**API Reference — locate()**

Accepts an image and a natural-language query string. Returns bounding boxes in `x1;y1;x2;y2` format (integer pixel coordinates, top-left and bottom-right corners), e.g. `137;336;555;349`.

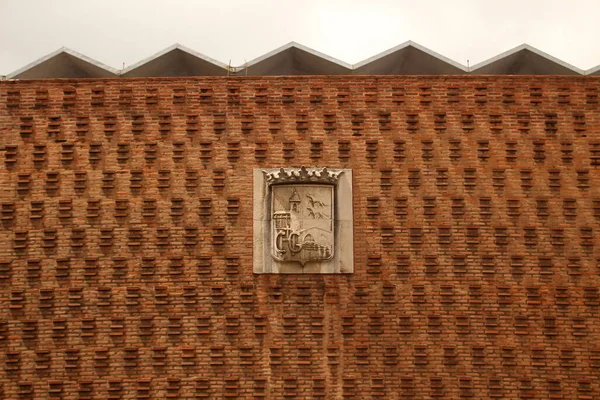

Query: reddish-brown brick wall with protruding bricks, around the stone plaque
0;77;600;399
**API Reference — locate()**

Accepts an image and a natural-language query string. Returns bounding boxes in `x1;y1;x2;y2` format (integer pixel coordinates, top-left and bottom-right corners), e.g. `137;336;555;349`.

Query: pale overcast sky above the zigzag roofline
0;0;600;75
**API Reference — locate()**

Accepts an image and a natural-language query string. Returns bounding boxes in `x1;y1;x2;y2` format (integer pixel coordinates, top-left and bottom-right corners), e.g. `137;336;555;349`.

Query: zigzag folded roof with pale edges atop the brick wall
6;41;600;79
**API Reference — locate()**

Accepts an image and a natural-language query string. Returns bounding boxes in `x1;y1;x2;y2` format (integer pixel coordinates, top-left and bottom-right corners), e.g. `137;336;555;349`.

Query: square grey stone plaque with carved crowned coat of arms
254;167;354;273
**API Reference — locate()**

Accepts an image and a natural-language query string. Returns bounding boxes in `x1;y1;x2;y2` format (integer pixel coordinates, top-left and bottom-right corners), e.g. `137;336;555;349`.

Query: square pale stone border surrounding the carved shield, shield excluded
253;168;354;274
